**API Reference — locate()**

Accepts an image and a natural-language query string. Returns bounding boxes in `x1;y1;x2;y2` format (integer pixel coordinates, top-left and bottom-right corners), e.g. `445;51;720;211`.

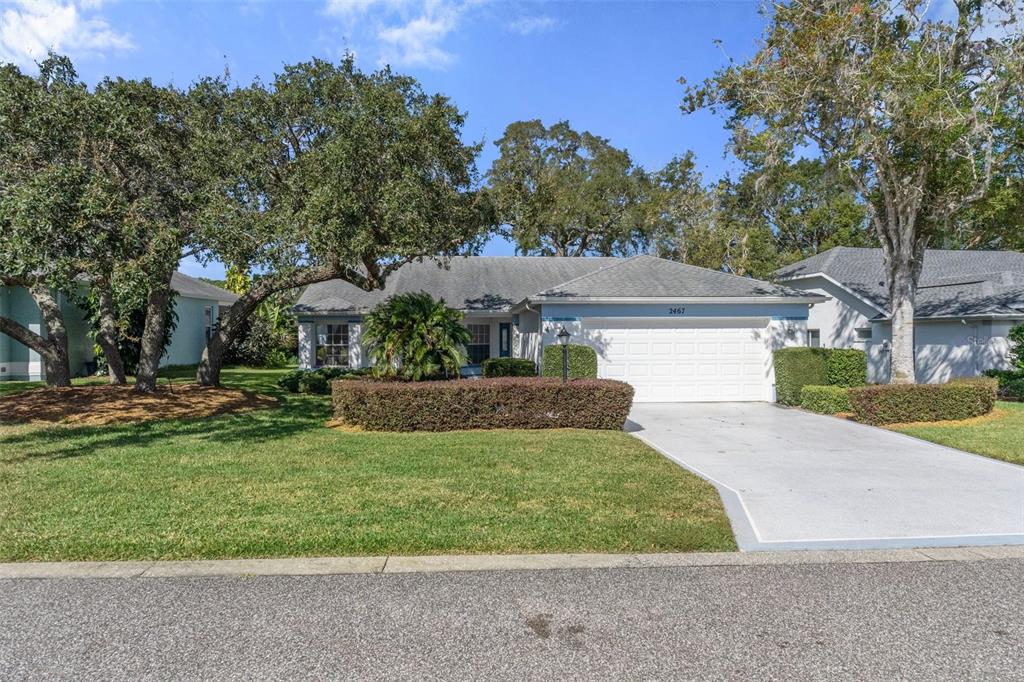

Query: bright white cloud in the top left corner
0;0;134;67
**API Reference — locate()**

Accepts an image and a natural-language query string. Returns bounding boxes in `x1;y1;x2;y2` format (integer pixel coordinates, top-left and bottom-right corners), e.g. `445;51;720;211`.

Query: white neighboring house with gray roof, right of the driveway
776;247;1024;383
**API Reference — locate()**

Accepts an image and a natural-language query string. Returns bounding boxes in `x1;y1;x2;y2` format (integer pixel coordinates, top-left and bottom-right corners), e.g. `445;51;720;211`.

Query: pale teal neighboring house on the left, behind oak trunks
0;272;238;381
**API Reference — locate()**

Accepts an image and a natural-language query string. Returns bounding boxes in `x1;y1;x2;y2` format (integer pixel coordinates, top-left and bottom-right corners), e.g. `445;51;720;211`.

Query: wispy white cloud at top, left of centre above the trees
325;0;475;69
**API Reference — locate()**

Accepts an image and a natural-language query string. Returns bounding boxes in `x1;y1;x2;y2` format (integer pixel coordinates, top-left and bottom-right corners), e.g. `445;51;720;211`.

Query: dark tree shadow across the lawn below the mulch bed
0;387;331;464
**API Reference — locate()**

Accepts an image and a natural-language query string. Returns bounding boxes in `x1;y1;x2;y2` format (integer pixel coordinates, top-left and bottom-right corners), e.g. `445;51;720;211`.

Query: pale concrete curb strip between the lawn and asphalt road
0;545;1024;580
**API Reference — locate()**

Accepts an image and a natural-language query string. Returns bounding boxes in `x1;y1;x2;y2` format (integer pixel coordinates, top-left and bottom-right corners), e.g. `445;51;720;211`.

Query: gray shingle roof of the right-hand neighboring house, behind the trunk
776;247;1024;317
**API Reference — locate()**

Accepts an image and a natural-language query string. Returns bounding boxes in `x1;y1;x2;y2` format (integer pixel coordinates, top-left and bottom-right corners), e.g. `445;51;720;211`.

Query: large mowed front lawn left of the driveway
0;370;735;561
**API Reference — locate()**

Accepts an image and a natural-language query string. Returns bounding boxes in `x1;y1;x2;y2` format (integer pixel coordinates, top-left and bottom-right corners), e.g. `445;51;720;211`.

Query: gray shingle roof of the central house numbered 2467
294;251;823;313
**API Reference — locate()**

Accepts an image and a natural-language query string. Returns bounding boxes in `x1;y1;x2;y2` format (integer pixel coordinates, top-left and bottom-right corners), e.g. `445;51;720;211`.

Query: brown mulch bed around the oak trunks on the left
0;384;276;426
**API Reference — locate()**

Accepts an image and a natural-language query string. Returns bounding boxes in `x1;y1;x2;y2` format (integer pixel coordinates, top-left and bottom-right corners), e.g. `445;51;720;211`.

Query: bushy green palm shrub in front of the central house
362;292;472;381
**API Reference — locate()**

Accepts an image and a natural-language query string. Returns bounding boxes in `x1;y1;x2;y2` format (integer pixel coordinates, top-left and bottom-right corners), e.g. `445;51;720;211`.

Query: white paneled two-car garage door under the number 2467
583;317;770;402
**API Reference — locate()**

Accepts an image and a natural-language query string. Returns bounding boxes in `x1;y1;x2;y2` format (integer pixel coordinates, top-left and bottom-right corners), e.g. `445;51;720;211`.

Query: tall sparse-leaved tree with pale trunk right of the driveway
683;0;1024;383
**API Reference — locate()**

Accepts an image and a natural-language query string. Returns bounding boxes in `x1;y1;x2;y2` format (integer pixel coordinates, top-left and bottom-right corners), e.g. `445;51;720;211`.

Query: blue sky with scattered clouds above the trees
0;0;763;276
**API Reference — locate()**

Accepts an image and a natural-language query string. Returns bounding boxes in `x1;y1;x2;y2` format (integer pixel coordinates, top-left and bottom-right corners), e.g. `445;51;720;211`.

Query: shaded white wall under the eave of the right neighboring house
867;319;1015;384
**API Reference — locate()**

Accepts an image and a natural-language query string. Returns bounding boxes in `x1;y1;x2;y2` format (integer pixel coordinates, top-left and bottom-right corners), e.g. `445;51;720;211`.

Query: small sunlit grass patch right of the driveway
893;402;1024;464
